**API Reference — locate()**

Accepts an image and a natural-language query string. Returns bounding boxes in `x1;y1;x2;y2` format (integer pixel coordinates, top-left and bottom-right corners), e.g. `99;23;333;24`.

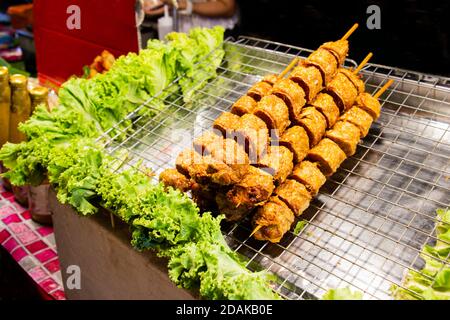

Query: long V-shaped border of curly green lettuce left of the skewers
0;27;279;299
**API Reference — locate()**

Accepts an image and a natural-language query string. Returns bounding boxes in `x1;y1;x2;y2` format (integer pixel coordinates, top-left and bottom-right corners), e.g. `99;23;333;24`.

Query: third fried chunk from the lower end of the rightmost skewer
289;160;327;196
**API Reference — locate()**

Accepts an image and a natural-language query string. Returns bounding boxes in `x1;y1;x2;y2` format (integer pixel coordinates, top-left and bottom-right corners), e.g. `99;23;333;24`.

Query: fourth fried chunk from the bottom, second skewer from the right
296;107;327;148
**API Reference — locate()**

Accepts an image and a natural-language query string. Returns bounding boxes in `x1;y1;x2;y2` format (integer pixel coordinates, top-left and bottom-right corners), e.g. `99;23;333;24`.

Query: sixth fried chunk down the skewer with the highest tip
235;114;269;162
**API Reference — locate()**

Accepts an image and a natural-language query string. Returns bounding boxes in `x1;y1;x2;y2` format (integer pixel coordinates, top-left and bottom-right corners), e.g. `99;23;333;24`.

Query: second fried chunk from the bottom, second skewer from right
256;146;294;186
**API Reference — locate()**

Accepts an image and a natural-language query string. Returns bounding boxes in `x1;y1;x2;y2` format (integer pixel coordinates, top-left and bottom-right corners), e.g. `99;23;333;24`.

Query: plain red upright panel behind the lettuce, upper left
33;0;139;88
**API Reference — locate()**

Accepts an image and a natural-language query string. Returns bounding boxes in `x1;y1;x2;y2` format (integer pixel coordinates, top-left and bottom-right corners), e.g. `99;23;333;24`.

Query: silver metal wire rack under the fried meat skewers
99;37;450;299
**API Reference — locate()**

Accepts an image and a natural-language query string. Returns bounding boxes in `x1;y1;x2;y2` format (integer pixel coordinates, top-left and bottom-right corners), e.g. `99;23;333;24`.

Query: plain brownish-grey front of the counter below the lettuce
49;190;195;300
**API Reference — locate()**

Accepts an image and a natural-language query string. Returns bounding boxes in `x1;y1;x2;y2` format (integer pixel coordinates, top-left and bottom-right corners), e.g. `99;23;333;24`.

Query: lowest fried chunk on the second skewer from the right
227;166;275;208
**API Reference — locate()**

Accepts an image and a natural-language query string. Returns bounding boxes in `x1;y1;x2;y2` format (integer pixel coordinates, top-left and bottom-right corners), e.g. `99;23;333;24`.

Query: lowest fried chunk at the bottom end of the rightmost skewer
253;196;295;243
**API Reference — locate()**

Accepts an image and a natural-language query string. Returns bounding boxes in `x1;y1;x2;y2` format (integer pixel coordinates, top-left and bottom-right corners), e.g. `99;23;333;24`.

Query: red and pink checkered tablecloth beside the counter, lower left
0;183;65;300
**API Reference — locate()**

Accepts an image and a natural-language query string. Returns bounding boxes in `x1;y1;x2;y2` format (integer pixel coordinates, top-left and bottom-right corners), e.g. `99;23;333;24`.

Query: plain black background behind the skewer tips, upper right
237;0;450;76
